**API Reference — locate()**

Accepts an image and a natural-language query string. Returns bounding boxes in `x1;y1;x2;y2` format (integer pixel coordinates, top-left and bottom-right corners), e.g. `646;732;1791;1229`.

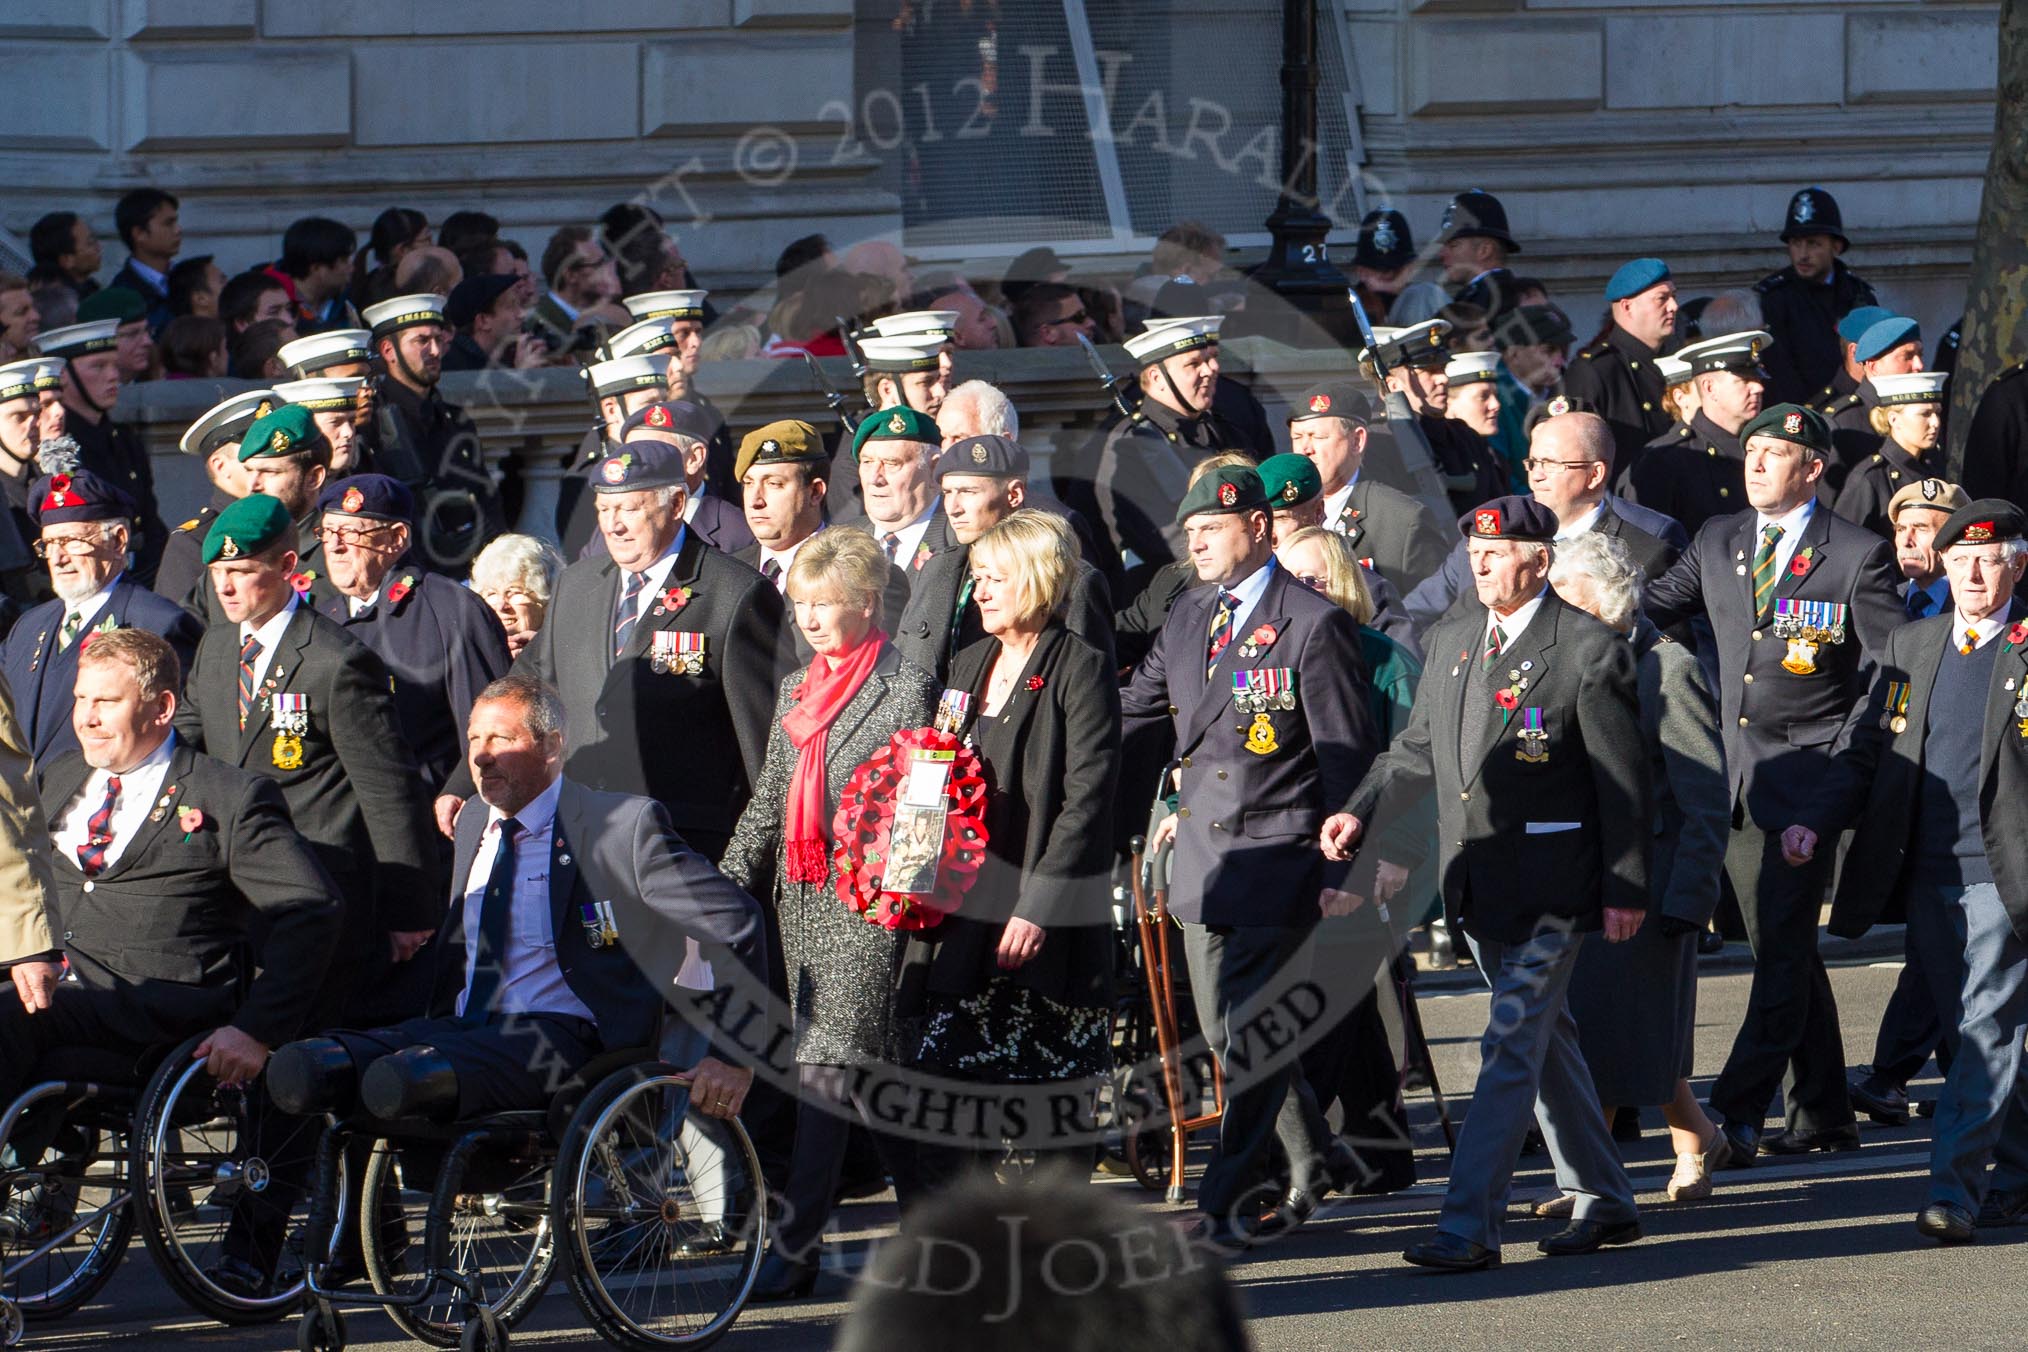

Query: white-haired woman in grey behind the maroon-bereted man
1537;531;1732;1214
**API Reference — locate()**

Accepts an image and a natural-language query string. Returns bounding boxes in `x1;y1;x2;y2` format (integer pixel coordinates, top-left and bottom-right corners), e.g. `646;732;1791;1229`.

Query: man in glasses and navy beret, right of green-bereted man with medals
316;474;509;799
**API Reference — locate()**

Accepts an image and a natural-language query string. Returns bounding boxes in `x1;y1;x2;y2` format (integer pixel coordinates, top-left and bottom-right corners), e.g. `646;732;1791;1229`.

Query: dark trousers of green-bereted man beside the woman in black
1182;924;1332;1224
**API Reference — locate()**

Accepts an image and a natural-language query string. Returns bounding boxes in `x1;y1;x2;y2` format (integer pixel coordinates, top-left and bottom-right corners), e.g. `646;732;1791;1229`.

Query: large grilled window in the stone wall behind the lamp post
896;0;1361;247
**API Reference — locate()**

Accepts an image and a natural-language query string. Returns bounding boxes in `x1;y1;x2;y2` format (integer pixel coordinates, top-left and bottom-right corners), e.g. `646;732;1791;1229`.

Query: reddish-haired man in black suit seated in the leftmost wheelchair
0;628;339;1243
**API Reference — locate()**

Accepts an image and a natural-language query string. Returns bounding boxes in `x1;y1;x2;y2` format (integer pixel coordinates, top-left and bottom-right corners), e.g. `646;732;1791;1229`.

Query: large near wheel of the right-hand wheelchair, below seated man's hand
556;1064;767;1352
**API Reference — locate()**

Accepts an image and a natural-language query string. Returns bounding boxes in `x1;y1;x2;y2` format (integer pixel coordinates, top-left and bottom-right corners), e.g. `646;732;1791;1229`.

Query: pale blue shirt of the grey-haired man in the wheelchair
458;778;592;1022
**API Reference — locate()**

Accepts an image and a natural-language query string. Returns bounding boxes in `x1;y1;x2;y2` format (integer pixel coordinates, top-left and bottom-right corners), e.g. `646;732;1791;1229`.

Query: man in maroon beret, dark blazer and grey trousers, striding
1322;497;1651;1271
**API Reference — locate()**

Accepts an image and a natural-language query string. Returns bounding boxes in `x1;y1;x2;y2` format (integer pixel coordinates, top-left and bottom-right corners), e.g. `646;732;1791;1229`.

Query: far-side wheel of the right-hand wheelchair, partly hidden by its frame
359;1141;556;1348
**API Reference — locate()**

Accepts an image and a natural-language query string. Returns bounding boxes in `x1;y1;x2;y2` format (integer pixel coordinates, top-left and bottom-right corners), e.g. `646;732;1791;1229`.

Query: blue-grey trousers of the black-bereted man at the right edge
1908;882;2028;1212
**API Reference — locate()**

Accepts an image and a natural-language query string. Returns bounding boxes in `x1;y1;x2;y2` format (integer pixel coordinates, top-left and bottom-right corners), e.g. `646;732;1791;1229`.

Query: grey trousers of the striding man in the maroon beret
1436;930;1639;1249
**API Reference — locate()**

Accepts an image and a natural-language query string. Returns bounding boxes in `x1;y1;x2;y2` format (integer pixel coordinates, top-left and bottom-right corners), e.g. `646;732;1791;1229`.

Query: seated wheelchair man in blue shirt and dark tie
268;675;767;1175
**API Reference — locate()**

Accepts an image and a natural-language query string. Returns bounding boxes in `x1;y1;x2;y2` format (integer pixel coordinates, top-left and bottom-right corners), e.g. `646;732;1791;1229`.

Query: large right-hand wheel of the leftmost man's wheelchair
134;1048;345;1324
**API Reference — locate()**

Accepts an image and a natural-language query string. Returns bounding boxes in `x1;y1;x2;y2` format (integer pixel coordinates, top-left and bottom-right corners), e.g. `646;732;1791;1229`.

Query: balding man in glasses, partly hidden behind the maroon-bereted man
1403;409;1689;632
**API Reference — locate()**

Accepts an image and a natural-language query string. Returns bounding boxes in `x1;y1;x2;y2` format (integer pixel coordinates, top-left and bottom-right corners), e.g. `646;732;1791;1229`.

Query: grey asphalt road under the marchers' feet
26;963;2028;1352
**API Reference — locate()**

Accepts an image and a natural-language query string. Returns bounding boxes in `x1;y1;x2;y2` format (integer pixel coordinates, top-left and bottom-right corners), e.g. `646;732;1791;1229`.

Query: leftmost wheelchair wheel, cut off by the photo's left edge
0;1091;134;1324
